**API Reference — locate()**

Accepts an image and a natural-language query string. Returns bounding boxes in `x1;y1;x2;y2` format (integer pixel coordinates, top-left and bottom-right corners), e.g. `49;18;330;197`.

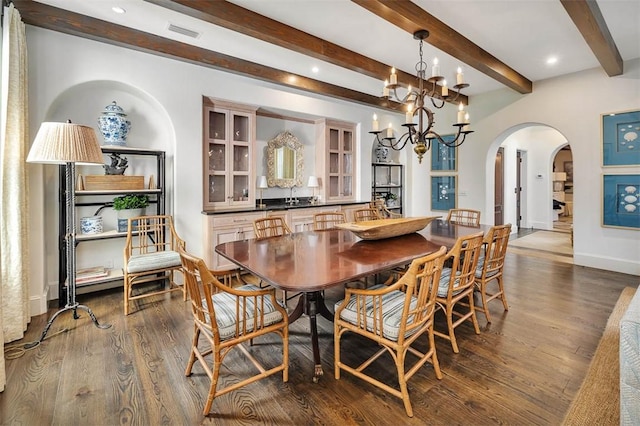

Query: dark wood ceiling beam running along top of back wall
13;0;402;112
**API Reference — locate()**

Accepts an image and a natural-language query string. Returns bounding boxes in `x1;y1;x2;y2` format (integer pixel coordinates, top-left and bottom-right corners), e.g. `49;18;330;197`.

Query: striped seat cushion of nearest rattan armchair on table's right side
334;284;416;341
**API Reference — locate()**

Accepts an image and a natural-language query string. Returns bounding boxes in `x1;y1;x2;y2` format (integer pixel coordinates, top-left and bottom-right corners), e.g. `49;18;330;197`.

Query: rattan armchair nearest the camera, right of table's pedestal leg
333;247;446;417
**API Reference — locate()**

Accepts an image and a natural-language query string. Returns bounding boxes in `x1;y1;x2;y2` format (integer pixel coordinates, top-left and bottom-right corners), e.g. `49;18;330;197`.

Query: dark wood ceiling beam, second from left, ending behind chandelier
144;0;469;105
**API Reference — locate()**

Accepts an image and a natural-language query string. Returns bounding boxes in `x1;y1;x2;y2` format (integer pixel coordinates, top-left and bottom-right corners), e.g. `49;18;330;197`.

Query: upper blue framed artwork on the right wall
602;111;640;167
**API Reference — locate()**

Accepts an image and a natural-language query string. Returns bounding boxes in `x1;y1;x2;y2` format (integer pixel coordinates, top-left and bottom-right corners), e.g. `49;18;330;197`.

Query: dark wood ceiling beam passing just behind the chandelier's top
351;0;533;93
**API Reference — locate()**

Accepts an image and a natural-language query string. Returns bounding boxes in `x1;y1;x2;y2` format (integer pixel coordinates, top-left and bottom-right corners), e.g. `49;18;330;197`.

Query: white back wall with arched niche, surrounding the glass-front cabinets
27;26;410;314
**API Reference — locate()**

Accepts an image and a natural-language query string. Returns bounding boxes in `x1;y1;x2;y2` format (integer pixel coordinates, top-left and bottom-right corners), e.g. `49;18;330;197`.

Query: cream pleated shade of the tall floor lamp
27;122;104;164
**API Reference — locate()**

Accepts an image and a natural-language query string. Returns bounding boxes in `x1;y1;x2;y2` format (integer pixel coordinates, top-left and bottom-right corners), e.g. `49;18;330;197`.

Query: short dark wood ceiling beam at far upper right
560;0;624;77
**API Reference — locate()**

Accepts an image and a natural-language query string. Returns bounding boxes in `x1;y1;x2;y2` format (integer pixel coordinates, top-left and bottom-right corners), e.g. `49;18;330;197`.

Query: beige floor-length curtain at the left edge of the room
0;4;30;391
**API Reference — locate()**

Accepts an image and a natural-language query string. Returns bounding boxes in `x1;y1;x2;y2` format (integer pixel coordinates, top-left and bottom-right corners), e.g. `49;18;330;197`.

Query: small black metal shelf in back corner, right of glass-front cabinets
371;163;404;214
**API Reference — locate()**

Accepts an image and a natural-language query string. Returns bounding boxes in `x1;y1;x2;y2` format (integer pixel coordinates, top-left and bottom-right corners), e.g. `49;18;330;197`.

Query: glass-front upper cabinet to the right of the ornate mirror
316;120;357;202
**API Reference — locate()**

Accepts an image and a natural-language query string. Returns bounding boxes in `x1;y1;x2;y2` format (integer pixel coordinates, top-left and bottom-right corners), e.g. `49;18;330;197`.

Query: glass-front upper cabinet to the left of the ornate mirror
202;97;257;211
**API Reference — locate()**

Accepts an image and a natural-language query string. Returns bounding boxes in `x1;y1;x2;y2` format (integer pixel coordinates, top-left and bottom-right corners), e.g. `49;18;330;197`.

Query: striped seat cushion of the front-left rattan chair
208;284;283;340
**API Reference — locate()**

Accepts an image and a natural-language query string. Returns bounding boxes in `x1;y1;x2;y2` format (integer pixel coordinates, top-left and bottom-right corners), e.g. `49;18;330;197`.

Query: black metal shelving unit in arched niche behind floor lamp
58;146;166;307
